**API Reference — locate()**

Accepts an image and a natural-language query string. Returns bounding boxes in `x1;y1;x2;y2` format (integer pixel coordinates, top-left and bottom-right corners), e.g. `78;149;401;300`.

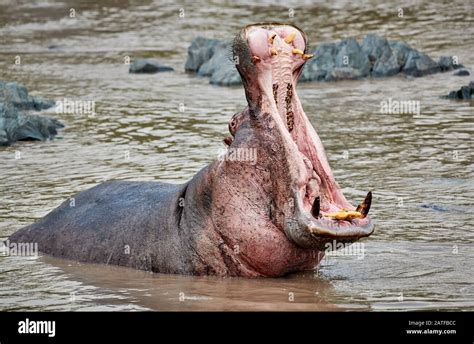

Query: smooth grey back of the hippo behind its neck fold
9;181;189;273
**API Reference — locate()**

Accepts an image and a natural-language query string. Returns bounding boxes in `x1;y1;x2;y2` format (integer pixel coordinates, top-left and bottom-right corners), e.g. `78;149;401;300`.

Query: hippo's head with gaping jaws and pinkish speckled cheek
207;24;374;276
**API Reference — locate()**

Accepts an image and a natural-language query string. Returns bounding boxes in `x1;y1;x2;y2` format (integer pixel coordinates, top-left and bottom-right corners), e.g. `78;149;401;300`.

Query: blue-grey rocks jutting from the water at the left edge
0;81;64;145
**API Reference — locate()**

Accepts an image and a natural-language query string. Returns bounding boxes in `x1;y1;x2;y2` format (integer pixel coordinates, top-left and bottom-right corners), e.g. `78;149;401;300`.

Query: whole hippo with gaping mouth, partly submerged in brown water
5;23;374;277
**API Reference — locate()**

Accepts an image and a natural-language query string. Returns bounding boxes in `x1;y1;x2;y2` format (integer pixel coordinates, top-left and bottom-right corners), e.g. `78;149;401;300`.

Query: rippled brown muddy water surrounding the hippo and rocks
0;0;474;310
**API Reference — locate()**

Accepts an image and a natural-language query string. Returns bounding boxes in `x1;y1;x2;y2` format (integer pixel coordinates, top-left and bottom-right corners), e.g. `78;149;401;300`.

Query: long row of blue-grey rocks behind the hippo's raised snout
185;33;462;85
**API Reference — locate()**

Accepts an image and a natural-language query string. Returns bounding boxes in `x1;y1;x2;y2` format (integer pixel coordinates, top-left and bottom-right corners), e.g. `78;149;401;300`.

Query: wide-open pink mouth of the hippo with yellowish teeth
231;24;374;250
